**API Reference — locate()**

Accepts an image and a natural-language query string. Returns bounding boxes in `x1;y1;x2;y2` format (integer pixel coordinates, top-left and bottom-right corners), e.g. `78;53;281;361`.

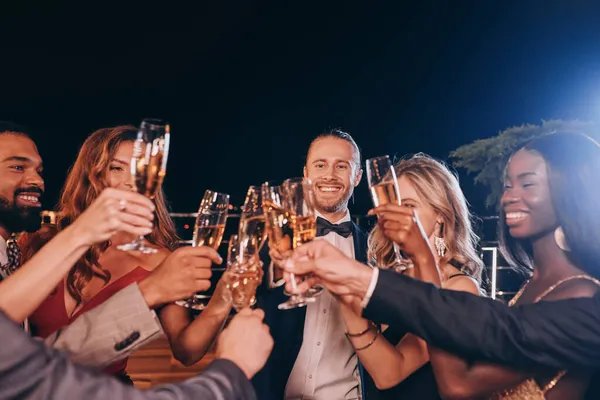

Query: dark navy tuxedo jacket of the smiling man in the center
252;223;371;400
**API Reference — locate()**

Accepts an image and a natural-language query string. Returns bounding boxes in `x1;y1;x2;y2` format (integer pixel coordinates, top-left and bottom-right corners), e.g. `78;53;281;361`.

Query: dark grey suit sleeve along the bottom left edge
0;312;256;400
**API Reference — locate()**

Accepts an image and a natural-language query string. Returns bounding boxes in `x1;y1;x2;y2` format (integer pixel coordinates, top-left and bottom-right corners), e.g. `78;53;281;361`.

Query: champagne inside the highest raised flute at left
131;135;169;199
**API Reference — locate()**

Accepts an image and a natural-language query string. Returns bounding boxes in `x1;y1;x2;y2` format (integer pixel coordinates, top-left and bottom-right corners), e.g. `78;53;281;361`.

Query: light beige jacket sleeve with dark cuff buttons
45;284;163;368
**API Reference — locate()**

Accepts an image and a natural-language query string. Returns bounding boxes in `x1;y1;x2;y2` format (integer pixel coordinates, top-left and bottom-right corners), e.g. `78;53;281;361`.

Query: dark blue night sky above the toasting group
0;0;600;228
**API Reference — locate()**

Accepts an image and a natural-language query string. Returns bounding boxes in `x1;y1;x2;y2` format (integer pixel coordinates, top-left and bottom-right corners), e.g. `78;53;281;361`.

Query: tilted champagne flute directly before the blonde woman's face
367;156;412;272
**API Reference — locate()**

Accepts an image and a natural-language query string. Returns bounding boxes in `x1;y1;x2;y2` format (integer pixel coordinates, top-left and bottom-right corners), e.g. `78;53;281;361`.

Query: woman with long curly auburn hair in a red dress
20;126;230;382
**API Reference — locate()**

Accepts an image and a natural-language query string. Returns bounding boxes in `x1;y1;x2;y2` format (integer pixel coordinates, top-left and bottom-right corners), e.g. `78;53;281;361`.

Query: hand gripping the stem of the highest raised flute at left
71;188;155;246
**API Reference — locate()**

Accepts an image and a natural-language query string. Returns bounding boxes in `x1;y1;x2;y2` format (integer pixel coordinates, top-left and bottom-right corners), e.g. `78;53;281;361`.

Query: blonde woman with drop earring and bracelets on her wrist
339;154;483;399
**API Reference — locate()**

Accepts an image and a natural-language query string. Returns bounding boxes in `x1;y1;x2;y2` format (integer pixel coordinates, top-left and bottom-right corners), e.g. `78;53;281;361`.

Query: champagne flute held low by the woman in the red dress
223;234;262;312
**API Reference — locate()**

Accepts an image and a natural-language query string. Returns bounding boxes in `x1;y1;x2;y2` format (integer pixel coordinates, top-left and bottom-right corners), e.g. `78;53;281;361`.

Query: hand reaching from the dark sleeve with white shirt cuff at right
278;240;373;298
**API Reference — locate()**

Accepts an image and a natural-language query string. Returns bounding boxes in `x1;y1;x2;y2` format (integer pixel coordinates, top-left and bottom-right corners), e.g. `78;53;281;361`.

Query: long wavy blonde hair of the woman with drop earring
368;153;483;283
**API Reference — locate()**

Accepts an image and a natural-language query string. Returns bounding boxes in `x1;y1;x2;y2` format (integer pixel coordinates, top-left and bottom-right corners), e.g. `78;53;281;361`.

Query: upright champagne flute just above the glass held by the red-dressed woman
238;186;267;251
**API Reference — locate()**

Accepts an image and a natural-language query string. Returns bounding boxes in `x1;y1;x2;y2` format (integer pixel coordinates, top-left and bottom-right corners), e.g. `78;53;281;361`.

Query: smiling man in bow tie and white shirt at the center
253;130;376;399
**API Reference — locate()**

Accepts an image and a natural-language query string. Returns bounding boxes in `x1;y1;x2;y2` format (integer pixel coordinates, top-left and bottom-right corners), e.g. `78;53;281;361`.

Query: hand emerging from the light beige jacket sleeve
139;246;223;308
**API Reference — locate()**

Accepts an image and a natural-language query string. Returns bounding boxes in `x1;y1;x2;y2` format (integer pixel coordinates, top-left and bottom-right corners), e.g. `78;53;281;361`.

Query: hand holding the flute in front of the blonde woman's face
369;203;433;262
